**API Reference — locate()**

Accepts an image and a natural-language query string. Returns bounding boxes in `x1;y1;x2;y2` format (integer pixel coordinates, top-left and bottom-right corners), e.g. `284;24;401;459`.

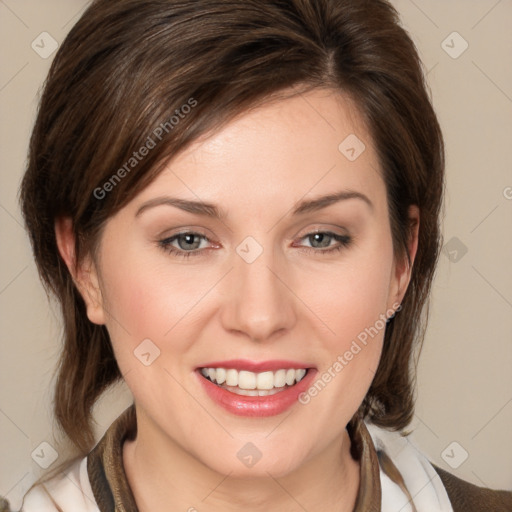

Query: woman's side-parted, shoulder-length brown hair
20;0;444;484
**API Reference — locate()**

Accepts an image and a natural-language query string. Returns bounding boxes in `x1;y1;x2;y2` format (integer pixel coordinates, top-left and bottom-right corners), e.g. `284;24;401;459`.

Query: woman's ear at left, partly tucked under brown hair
55;217;105;325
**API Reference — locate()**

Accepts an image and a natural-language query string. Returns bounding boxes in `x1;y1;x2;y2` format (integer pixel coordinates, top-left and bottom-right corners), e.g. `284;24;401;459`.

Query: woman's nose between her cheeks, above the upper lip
221;241;298;343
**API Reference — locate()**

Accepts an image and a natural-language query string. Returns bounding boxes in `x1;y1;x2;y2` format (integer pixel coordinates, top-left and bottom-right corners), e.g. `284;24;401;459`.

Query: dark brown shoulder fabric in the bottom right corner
432;464;512;512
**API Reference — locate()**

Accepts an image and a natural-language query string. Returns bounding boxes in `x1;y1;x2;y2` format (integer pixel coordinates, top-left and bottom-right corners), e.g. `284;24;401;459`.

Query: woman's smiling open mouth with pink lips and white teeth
196;360;317;416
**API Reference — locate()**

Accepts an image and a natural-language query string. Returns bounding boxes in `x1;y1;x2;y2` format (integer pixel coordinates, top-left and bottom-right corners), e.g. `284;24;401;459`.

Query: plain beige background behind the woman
0;0;512;508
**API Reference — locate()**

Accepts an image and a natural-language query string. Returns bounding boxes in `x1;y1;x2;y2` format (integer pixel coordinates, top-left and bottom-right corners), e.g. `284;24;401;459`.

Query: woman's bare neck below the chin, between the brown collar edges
123;410;360;512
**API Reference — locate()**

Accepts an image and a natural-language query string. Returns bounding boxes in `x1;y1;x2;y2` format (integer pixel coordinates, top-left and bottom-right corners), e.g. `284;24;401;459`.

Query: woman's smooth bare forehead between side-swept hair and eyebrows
127;89;385;215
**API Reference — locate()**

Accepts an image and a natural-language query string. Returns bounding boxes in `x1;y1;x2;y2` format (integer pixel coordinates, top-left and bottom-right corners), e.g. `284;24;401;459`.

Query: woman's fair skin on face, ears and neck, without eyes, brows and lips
56;89;419;512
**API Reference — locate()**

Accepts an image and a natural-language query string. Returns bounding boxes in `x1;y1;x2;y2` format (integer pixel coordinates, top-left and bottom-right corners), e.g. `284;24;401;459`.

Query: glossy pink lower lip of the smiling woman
196;368;317;417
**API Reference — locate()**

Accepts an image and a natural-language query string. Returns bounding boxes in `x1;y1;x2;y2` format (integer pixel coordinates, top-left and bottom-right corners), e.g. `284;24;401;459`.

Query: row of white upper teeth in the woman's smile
201;368;306;390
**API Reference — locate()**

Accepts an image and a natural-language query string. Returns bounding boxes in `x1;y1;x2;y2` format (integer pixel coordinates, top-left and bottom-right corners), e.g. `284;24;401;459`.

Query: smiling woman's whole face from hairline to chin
79;90;415;476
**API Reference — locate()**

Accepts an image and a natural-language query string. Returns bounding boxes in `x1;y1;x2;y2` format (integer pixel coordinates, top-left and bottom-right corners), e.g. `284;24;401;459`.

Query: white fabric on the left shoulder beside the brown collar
20;457;99;512
